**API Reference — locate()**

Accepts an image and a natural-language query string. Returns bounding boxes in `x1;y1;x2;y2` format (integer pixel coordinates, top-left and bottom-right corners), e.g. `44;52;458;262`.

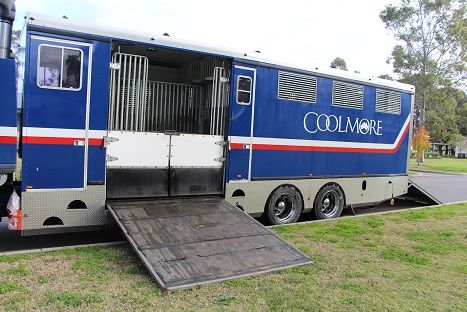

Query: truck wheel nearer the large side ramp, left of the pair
264;185;303;225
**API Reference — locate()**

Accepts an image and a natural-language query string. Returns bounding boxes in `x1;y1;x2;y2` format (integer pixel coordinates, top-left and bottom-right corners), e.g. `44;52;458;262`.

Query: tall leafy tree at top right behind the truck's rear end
380;0;467;132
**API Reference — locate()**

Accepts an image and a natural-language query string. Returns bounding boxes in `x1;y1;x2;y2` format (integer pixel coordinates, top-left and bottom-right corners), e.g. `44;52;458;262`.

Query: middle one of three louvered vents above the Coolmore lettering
332;81;363;109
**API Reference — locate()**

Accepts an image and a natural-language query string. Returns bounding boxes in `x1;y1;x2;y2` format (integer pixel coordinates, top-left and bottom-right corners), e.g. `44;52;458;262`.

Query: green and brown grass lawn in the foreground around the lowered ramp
0;204;467;311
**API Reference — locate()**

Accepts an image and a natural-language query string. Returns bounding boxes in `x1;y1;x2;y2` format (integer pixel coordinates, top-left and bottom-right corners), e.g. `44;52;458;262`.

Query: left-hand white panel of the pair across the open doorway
107;131;170;168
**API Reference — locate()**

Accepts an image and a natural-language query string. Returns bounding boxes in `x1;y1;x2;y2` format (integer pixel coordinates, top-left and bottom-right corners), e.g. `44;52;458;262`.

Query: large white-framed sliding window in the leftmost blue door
37;45;83;91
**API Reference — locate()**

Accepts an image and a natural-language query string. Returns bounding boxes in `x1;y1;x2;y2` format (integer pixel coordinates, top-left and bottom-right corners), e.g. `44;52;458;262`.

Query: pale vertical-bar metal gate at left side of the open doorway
109;53;149;131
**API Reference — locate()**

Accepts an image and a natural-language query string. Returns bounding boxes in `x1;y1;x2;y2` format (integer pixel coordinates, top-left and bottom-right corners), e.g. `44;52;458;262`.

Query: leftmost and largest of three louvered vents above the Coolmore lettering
277;71;316;103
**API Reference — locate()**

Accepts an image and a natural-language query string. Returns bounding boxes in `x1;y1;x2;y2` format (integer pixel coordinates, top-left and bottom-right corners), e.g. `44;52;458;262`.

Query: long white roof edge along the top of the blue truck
26;13;415;93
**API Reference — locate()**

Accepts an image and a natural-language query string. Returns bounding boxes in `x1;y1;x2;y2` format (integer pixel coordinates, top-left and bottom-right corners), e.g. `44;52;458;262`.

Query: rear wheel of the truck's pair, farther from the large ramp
313;184;345;220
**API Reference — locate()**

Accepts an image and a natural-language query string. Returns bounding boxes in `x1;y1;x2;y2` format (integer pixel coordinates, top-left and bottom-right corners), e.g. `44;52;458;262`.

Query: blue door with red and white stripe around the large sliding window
23;33;92;189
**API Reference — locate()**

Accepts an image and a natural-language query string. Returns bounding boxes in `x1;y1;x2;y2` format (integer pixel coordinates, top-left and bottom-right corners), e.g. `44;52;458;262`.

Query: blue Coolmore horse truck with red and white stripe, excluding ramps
0;4;414;235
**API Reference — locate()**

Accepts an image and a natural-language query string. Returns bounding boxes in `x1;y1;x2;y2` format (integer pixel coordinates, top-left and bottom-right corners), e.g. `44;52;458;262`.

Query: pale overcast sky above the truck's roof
14;0;398;76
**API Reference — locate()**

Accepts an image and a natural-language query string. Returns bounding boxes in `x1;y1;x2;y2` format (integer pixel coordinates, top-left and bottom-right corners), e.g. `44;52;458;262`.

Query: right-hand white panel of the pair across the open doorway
170;134;224;168
